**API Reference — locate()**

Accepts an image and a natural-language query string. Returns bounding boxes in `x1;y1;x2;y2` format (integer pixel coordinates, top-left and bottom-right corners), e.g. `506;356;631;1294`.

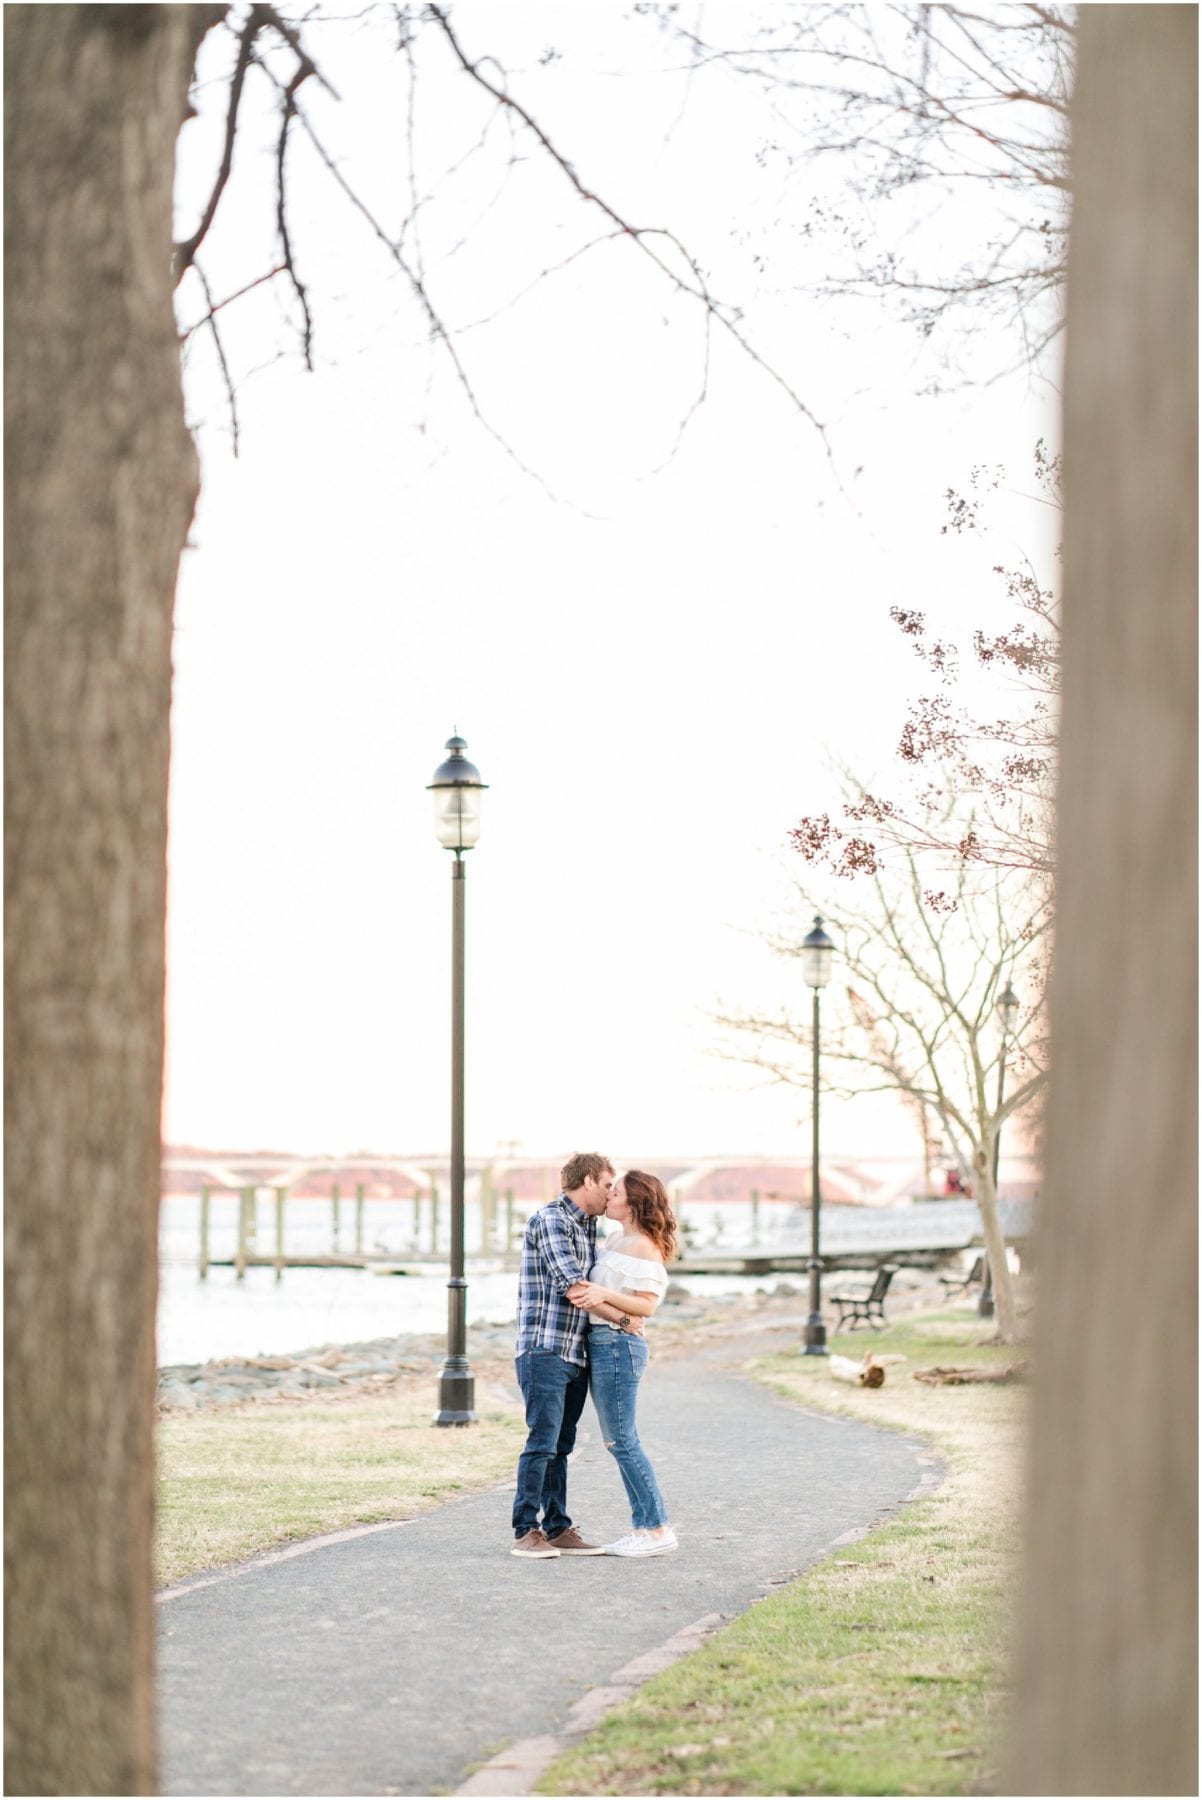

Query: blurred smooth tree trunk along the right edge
1004;5;1198;1795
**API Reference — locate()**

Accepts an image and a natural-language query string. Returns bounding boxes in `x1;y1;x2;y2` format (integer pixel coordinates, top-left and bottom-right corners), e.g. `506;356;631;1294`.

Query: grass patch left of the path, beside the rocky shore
155;1384;525;1586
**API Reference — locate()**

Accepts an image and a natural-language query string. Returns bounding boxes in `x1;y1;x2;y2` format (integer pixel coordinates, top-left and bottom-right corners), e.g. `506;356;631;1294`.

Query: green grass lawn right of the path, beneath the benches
538;1310;1026;1795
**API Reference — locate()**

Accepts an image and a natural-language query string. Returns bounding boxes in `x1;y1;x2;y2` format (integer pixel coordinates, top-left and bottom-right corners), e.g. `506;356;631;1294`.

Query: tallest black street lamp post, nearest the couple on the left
430;736;486;1426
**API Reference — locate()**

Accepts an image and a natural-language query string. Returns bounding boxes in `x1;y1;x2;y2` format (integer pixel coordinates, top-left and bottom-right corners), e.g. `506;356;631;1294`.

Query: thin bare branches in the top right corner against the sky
637;0;1076;387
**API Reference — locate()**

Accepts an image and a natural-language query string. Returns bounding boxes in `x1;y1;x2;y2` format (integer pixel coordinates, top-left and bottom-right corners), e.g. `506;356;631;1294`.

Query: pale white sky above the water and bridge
164;4;1056;1156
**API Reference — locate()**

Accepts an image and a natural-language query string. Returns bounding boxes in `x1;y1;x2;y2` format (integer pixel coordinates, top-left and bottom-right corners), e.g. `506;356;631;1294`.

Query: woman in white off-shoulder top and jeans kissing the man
572;1168;680;1557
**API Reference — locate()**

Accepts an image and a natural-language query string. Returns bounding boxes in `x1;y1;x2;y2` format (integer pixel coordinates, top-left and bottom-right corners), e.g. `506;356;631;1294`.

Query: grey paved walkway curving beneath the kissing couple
158;1332;923;1795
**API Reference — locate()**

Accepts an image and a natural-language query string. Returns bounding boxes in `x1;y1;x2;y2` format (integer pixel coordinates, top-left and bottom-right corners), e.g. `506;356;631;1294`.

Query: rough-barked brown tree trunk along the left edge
4;5;214;1795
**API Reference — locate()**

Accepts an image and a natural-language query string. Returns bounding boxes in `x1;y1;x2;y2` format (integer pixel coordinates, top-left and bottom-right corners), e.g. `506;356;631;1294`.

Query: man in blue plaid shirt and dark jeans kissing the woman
513;1154;632;1557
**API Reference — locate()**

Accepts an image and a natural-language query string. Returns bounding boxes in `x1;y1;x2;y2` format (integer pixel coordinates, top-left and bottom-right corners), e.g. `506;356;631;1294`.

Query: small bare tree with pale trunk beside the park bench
714;851;1051;1343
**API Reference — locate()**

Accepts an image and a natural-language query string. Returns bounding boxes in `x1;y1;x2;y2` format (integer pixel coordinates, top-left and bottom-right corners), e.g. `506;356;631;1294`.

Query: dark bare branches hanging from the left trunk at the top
173;4;830;488
